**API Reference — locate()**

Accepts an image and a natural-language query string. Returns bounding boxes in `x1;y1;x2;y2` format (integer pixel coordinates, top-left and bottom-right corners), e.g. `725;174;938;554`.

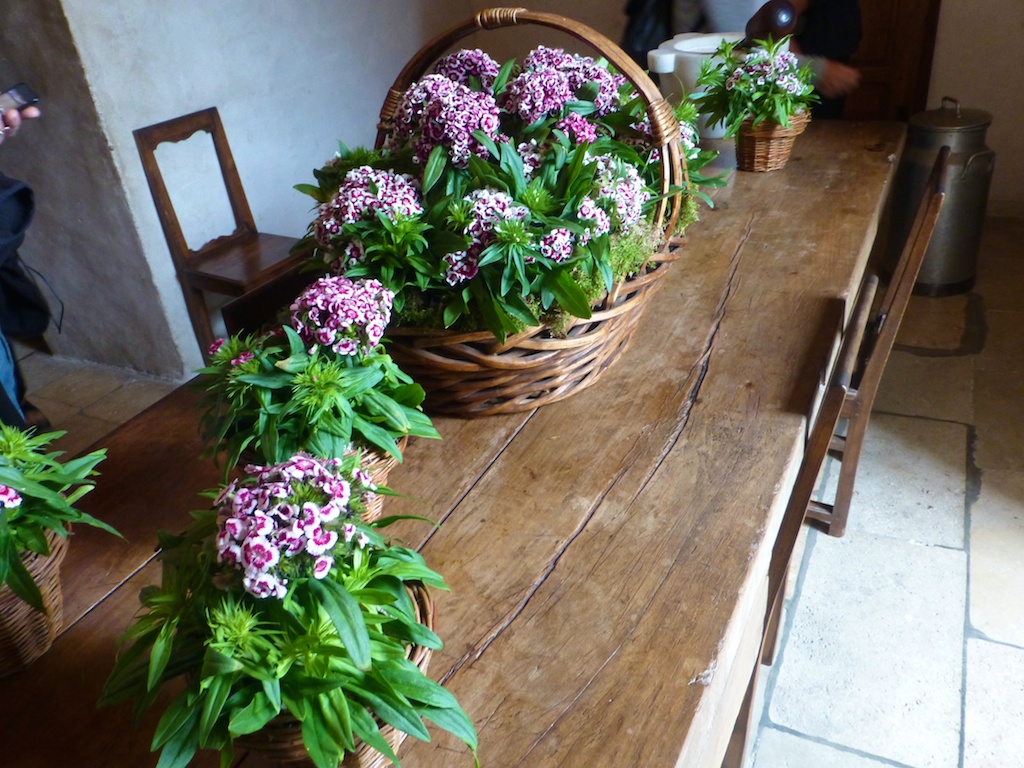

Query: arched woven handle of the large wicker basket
376;8;689;236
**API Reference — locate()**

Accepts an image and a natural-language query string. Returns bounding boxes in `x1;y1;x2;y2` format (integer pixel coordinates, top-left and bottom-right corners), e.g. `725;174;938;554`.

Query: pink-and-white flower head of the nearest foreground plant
215;454;377;598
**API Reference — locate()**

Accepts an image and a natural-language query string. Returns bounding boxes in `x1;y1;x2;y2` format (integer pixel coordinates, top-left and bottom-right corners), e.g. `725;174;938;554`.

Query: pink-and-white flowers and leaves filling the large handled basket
297;46;693;338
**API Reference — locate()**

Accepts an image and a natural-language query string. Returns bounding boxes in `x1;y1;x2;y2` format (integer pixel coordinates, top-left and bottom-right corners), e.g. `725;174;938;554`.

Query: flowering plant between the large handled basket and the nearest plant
199;275;439;467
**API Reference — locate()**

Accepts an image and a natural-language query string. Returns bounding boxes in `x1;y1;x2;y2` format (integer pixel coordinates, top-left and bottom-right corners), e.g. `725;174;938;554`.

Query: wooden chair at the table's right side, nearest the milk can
807;146;949;537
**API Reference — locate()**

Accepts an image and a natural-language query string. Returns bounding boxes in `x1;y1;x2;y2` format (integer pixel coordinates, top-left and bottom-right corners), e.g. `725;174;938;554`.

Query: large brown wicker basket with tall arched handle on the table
377;8;688;417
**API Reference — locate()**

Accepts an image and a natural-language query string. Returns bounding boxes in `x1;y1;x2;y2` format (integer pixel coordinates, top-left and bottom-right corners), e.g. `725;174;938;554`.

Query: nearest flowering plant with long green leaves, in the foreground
100;454;477;768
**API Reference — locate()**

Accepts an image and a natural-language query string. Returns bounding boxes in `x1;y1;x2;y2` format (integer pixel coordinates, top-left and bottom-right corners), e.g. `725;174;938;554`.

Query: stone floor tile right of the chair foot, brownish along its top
821;414;968;549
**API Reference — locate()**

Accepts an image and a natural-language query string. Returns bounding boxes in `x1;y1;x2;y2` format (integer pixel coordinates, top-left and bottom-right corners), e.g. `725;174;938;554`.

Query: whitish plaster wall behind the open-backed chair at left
63;0;471;371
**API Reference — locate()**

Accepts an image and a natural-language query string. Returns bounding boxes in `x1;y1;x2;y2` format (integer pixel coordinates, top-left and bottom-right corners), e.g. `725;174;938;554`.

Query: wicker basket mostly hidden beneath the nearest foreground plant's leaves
234;585;434;768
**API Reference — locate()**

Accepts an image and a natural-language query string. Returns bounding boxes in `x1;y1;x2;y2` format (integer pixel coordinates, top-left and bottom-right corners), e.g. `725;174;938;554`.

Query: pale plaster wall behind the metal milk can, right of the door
928;0;1024;218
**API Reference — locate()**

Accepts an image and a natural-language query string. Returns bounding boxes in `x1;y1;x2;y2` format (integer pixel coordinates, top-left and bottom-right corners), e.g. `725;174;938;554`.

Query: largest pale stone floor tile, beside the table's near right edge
768;531;967;768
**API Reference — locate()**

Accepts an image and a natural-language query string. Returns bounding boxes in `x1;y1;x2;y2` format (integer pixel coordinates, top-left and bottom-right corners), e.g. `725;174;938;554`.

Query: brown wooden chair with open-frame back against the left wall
133;108;302;358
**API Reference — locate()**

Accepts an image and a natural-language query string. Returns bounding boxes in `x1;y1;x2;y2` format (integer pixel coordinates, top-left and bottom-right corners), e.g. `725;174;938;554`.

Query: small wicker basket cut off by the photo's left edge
0;531;68;678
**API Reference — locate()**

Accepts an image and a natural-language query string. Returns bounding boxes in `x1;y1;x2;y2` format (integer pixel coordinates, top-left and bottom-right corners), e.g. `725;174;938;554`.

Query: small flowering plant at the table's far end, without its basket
694;37;818;136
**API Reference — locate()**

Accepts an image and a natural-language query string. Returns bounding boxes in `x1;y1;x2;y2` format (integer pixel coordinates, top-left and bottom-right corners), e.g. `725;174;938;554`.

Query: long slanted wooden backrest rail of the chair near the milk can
854;146;949;397
